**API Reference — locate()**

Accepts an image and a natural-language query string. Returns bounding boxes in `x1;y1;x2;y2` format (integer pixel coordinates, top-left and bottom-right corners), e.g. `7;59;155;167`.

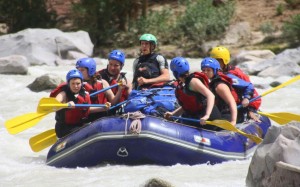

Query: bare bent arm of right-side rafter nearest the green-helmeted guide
190;78;215;124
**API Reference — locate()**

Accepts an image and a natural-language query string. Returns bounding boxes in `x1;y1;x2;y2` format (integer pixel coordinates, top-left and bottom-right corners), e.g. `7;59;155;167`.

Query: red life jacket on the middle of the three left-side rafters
84;81;107;104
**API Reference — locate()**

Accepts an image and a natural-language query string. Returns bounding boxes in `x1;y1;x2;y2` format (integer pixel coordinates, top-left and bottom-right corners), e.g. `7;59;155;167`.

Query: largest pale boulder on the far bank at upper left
0;29;94;65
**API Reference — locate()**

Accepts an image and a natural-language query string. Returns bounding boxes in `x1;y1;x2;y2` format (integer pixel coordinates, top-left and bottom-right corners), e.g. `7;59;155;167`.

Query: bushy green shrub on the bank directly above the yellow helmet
174;0;234;47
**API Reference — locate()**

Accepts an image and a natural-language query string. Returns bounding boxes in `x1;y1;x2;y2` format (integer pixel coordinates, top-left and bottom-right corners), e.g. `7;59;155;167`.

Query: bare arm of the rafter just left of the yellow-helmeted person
216;83;237;125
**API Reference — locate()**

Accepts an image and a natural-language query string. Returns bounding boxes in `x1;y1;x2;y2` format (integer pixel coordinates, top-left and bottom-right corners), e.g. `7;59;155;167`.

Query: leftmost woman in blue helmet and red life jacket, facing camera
50;69;91;138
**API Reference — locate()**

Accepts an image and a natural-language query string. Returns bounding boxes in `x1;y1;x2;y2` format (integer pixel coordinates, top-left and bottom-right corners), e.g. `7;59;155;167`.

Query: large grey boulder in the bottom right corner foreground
246;123;300;187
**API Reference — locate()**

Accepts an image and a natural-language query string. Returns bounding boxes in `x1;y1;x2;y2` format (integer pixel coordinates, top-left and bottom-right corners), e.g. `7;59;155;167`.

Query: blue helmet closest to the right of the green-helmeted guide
170;57;190;79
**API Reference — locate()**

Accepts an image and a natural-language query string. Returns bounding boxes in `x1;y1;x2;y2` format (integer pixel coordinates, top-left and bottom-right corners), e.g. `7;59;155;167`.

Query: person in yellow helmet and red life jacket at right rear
210;46;261;122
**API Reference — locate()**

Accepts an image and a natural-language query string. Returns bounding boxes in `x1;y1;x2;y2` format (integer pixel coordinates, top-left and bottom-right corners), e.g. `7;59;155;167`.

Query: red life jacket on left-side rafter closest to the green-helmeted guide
98;69;128;102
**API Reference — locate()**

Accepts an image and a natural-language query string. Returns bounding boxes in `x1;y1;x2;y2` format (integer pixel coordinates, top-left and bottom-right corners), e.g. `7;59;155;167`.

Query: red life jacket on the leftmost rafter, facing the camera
50;83;91;125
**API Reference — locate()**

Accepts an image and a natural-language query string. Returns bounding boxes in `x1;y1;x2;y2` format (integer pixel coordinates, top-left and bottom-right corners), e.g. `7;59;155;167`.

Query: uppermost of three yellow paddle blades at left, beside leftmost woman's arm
37;97;68;113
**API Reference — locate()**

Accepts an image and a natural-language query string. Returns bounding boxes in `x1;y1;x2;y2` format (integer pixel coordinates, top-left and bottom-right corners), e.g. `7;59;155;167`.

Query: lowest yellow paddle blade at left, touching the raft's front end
29;129;57;152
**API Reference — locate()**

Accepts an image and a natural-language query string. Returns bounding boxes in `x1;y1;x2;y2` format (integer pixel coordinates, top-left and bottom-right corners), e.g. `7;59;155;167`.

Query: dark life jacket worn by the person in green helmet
133;53;164;89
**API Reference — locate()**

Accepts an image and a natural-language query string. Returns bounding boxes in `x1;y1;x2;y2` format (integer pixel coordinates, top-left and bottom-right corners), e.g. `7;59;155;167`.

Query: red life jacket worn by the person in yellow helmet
226;65;261;110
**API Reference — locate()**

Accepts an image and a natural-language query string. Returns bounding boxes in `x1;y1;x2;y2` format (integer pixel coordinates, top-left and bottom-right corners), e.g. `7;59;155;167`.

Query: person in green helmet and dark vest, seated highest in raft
132;34;170;90
